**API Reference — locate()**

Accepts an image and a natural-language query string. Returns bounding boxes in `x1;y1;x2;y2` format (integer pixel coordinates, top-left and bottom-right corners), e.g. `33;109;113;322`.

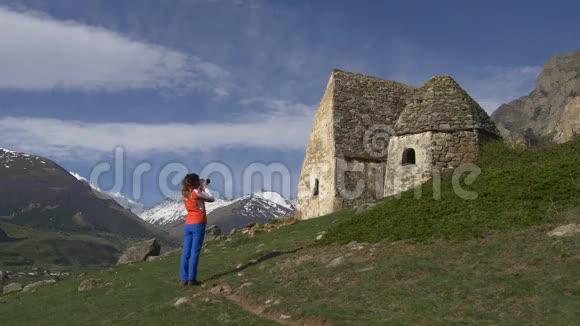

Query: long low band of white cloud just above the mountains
0;105;314;161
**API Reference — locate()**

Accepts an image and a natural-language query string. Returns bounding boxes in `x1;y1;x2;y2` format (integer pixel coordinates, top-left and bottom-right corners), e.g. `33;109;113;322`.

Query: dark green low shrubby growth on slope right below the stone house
324;140;580;244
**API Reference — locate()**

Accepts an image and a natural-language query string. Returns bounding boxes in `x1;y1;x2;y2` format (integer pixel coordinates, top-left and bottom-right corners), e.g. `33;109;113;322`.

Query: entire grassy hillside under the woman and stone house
0;141;580;325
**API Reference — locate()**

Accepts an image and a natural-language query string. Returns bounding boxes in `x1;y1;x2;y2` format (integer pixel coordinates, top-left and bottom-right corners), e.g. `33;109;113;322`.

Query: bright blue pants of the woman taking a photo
180;224;205;281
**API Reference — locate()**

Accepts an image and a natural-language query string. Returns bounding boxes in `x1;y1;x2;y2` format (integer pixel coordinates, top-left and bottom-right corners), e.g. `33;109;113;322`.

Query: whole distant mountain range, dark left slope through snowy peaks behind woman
0;145;294;266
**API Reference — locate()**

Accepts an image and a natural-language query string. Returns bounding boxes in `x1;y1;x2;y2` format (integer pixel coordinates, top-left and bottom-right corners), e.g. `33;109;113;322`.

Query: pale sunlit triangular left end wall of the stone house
296;76;335;219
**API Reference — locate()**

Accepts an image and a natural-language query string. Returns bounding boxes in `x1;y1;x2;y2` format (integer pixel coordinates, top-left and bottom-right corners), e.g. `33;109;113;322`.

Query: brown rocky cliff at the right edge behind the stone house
492;51;580;146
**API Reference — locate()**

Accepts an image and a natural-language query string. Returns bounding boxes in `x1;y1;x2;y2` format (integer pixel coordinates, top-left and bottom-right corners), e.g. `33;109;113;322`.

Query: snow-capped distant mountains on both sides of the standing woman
139;192;294;236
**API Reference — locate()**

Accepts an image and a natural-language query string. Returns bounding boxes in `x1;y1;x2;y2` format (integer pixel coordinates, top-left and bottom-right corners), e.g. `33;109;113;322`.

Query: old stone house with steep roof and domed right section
296;70;501;219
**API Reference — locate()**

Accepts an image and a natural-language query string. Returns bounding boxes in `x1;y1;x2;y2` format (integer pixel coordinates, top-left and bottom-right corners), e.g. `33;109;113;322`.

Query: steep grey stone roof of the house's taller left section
331;69;415;159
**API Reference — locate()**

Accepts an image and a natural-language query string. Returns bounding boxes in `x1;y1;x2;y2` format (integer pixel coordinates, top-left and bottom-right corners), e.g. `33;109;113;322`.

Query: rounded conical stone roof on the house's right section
395;76;500;137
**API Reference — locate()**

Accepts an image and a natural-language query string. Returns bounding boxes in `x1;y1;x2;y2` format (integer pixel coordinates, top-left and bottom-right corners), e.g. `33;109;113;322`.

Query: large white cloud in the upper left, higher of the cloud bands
0;7;229;96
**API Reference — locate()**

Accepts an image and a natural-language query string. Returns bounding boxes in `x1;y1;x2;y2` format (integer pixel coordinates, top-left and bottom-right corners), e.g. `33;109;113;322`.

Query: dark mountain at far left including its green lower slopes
0;149;175;266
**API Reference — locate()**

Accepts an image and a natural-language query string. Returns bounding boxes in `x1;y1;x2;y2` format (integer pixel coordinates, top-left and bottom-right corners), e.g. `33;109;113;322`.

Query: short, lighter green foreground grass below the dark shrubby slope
0;212;580;325
